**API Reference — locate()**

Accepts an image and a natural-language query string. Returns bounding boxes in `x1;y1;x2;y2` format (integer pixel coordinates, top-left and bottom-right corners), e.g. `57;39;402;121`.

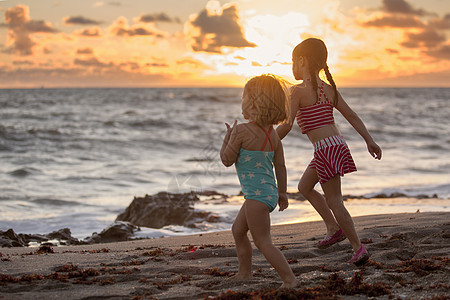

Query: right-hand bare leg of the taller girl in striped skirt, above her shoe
322;174;361;252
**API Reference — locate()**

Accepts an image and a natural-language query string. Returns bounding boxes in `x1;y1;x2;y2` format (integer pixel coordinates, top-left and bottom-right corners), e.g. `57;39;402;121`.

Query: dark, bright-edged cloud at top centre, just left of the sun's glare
188;2;256;53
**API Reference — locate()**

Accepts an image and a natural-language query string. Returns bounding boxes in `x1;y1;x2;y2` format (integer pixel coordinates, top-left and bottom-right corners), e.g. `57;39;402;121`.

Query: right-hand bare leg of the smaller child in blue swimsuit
245;200;298;288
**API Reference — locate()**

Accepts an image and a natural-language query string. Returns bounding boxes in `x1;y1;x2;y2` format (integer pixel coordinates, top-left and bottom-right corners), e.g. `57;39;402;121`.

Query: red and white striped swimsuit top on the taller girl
296;82;334;133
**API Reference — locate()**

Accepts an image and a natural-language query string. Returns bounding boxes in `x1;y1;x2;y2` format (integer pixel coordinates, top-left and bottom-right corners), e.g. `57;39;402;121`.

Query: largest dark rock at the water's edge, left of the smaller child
116;192;220;228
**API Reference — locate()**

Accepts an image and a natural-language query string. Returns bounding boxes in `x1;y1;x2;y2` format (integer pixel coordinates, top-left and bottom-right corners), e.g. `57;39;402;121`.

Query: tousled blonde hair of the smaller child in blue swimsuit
244;74;289;125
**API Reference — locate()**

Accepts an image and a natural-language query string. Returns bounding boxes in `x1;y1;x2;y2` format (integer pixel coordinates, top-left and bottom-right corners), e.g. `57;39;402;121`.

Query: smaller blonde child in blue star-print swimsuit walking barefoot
220;75;297;288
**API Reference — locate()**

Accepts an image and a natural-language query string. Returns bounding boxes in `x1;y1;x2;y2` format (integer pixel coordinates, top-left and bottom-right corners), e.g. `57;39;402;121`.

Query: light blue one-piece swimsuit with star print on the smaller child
235;126;278;212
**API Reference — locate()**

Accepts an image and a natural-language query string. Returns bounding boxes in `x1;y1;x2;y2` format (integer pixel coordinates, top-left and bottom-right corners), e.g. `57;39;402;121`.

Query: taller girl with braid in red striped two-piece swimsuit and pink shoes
277;38;381;265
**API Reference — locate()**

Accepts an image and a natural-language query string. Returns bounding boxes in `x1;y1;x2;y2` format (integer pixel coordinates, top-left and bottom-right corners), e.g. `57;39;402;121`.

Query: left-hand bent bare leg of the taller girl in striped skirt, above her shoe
298;168;339;236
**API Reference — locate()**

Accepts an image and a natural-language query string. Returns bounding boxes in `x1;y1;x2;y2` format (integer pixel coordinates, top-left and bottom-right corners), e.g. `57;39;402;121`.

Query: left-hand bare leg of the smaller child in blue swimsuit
231;201;252;279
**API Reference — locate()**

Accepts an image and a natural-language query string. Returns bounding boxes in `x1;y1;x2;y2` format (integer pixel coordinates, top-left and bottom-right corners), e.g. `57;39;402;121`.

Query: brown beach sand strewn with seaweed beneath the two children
0;212;450;299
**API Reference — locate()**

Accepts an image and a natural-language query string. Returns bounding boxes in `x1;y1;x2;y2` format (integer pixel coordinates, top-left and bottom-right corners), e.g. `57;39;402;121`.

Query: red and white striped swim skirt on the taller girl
308;135;356;183
